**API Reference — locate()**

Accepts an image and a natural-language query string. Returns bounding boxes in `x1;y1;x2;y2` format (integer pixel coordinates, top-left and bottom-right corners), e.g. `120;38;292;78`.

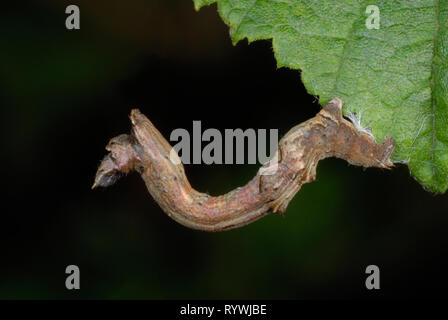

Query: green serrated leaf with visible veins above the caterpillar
194;0;448;192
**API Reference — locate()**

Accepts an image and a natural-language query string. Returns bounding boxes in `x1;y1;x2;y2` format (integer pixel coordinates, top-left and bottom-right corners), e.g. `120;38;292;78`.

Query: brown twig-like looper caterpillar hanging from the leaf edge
93;98;395;231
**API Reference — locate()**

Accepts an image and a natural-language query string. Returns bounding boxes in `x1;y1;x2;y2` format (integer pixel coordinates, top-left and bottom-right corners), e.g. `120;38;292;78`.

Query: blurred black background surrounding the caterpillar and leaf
0;0;448;299
